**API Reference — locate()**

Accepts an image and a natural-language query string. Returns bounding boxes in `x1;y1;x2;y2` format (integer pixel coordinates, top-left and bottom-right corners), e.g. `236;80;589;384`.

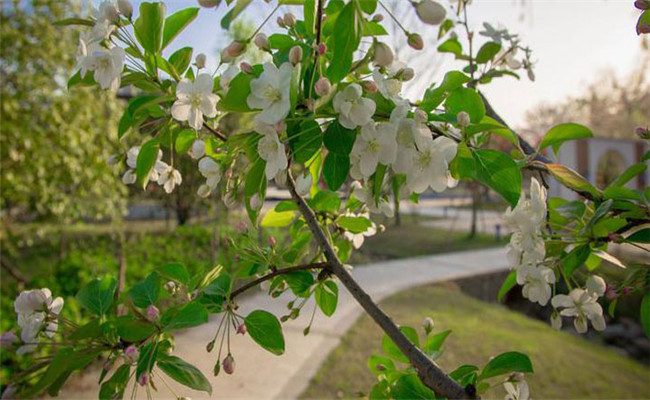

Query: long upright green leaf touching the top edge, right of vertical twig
327;1;363;84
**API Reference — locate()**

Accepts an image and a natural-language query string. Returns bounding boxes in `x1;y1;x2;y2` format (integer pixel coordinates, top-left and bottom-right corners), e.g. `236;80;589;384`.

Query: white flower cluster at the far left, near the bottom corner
14;288;63;354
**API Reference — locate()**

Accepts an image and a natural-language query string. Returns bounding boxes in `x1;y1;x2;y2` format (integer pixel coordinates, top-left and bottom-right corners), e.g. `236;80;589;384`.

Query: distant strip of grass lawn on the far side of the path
350;214;506;265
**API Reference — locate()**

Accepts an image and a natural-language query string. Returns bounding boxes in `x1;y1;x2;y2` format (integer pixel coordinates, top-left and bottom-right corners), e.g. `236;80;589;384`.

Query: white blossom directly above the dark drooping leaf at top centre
333;83;376;129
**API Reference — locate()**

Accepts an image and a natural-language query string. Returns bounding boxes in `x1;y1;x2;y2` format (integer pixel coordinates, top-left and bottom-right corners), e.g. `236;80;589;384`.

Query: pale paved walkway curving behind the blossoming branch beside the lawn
68;248;507;399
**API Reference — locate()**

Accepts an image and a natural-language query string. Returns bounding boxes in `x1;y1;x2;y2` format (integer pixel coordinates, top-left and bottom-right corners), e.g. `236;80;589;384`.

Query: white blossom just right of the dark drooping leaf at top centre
351;122;397;178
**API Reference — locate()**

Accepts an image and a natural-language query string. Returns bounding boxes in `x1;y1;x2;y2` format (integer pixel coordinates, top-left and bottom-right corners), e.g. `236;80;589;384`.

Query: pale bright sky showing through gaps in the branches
109;0;642;127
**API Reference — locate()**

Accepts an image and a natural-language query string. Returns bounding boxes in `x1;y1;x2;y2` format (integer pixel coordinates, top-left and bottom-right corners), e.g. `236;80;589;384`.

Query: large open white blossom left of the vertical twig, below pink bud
246;62;293;124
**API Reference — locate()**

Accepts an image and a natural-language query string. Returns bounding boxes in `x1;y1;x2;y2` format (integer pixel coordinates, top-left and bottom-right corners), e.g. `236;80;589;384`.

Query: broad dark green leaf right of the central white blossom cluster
472;150;521;207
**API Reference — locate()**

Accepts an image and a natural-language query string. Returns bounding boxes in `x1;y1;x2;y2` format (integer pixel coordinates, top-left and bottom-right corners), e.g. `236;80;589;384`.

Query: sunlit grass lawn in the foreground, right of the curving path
301;284;650;399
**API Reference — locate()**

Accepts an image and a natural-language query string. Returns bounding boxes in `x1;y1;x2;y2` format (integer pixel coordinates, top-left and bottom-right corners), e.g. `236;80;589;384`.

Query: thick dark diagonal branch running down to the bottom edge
287;172;475;399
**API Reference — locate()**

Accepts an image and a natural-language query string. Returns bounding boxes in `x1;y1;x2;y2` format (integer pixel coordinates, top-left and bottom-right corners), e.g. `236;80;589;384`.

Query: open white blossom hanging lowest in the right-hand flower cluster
551;288;605;333
